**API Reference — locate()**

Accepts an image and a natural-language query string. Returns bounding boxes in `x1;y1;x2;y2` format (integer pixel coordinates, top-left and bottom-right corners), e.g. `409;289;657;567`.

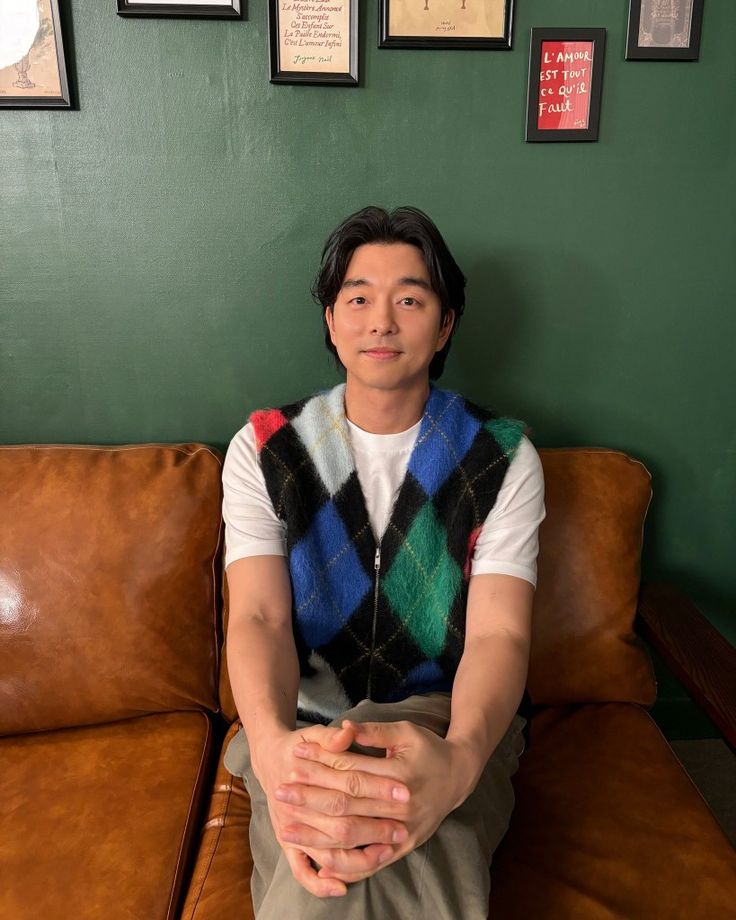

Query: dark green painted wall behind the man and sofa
0;0;736;656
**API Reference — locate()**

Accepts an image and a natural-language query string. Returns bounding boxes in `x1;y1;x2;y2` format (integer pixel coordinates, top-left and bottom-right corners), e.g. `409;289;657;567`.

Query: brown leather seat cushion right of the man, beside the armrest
491;703;736;920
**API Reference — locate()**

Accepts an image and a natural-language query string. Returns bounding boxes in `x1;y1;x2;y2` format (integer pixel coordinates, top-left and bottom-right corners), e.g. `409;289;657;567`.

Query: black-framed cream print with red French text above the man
268;0;358;86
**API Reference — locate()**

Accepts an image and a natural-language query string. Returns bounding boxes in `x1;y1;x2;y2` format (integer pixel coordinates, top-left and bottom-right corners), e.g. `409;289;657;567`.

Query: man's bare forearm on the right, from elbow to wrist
447;630;529;804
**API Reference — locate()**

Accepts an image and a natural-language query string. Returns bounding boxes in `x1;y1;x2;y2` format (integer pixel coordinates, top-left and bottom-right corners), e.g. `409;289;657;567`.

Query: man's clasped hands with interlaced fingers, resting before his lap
254;719;467;897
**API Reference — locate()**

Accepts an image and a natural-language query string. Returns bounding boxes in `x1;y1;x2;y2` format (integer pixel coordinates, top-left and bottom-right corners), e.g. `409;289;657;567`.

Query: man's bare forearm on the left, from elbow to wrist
226;617;299;750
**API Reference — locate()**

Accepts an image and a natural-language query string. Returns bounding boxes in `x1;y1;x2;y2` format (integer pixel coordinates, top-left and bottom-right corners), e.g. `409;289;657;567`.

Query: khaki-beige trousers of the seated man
224;693;526;920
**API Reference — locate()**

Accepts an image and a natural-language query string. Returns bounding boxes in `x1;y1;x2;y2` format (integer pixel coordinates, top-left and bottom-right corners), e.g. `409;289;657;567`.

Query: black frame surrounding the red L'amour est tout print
526;28;606;143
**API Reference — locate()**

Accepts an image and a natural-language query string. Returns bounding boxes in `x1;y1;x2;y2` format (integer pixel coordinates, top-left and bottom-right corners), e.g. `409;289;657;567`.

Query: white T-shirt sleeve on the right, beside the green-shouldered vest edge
470;435;546;588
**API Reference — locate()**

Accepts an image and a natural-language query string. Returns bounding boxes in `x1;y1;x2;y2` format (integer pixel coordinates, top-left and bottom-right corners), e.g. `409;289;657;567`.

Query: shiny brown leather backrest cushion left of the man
0;444;223;734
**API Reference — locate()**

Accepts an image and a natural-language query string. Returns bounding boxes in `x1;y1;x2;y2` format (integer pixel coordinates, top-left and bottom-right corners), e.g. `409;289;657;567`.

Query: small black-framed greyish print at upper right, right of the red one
626;0;703;61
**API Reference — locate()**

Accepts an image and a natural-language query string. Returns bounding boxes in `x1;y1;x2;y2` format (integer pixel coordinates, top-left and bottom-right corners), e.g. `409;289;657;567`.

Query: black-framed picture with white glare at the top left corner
0;0;71;109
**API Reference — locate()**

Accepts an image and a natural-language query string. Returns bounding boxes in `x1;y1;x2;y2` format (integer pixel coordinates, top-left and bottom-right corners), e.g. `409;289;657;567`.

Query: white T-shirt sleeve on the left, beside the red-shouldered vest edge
222;422;286;568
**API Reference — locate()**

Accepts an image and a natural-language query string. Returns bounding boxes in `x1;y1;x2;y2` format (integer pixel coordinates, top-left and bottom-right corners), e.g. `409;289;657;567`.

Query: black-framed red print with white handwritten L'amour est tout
526;29;606;141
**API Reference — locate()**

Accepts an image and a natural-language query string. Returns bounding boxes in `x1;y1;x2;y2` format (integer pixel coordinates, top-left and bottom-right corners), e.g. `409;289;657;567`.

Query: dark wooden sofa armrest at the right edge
636;582;736;750
